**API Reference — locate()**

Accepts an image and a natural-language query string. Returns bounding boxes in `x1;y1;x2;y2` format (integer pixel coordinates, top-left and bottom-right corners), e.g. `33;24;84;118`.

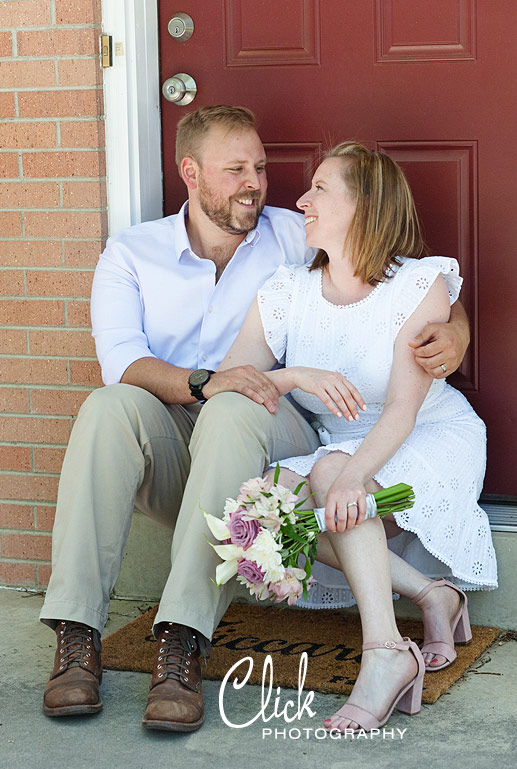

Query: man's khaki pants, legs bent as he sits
40;384;319;638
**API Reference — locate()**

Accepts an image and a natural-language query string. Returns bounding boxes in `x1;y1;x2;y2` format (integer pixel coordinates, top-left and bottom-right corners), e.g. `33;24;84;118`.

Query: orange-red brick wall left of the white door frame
0;0;107;587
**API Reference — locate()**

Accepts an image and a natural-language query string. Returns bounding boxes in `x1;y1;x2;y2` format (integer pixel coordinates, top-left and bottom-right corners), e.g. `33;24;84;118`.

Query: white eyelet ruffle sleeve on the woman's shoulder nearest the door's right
393;256;463;333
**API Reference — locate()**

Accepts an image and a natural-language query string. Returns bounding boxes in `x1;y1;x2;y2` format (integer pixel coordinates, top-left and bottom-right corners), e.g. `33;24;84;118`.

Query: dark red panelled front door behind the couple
160;0;517;497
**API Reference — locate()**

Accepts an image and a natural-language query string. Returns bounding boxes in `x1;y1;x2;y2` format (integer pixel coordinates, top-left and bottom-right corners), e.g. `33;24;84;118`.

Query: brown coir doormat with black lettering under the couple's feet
102;604;499;703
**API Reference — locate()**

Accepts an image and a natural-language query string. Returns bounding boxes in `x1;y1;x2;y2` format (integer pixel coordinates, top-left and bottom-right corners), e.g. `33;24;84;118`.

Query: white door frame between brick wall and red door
102;0;163;235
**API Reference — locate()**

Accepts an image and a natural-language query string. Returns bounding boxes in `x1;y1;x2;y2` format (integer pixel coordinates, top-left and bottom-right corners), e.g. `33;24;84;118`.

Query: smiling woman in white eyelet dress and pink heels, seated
216;142;497;731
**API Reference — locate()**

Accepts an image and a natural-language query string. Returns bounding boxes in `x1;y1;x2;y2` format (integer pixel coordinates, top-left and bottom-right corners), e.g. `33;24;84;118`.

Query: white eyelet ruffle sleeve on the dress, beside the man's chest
257;266;296;363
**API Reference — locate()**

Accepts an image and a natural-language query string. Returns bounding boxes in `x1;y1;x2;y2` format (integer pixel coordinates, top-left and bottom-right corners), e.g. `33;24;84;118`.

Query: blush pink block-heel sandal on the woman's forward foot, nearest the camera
323;638;425;734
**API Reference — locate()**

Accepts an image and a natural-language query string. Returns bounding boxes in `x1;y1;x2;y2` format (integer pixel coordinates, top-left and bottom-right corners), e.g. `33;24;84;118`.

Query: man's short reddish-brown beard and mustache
199;177;264;235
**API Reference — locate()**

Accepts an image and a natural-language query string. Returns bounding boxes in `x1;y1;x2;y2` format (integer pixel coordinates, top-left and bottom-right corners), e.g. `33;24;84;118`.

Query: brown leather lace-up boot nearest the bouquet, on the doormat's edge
142;622;210;732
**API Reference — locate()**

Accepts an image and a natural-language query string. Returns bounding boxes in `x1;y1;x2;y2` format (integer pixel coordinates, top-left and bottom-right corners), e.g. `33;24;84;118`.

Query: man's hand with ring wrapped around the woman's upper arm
409;323;470;379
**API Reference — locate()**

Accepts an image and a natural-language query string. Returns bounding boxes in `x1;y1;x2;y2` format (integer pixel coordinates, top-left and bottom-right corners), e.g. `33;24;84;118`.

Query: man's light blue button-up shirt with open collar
91;204;314;384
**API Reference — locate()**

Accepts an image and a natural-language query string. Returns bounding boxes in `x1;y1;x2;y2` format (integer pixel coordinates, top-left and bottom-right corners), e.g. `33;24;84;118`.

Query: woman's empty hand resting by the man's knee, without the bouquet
292;366;366;422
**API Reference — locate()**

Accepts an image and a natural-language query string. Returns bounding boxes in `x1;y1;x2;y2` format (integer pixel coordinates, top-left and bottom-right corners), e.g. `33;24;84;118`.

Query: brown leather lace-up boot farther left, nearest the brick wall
43;620;102;716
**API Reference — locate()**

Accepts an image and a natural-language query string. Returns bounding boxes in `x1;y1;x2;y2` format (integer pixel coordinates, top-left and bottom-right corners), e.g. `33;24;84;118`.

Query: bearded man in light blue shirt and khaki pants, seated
41;106;468;731
